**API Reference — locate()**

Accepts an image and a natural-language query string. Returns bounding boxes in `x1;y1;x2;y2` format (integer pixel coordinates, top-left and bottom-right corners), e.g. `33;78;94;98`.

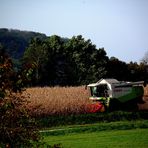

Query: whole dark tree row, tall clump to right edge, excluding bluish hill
24;35;148;86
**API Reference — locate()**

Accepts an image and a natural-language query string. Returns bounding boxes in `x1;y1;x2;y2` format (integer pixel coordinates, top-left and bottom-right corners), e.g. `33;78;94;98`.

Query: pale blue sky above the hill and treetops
0;0;148;62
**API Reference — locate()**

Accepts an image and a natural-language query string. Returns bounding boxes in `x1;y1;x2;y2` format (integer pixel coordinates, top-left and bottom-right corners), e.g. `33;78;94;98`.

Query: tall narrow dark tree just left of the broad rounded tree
43;35;67;85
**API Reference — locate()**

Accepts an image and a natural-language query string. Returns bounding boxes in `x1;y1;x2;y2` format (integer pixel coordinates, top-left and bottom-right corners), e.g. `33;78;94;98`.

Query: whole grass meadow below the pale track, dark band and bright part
41;120;148;148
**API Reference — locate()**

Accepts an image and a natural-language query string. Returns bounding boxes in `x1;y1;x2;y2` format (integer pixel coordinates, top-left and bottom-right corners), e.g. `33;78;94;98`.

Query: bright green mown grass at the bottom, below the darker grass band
44;129;148;148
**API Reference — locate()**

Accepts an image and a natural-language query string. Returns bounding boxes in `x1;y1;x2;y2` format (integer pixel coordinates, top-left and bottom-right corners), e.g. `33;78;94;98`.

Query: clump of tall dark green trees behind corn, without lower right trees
24;35;108;86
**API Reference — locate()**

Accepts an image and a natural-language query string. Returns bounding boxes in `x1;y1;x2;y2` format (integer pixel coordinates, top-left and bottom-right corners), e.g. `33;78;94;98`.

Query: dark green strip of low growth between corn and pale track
36;111;148;127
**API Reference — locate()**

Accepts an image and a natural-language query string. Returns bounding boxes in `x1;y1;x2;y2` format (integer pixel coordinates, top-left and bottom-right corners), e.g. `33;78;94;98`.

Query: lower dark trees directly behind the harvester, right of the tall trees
106;57;148;81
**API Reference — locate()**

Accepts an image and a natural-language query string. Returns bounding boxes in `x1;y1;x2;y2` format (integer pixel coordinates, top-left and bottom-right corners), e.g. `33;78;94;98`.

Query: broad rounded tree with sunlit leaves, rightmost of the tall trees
66;35;108;85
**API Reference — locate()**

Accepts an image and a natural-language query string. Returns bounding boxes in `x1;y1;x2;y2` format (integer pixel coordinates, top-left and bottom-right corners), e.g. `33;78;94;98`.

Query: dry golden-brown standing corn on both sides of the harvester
24;86;148;116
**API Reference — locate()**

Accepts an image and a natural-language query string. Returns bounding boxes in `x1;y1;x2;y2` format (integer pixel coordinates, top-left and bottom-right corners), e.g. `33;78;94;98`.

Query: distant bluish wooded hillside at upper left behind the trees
0;28;46;59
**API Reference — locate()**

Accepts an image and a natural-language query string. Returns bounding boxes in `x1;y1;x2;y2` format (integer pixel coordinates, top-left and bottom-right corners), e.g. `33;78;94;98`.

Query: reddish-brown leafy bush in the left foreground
0;46;40;148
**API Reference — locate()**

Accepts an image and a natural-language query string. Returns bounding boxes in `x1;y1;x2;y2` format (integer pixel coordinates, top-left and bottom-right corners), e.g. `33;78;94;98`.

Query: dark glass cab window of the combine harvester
91;84;109;97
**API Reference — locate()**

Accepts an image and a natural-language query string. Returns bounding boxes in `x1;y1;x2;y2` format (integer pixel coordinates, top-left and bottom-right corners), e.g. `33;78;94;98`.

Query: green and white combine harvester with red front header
88;79;144;112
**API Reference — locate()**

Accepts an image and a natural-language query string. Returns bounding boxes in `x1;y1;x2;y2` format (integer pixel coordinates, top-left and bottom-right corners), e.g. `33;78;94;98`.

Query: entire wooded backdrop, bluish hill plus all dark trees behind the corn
0;29;148;86
